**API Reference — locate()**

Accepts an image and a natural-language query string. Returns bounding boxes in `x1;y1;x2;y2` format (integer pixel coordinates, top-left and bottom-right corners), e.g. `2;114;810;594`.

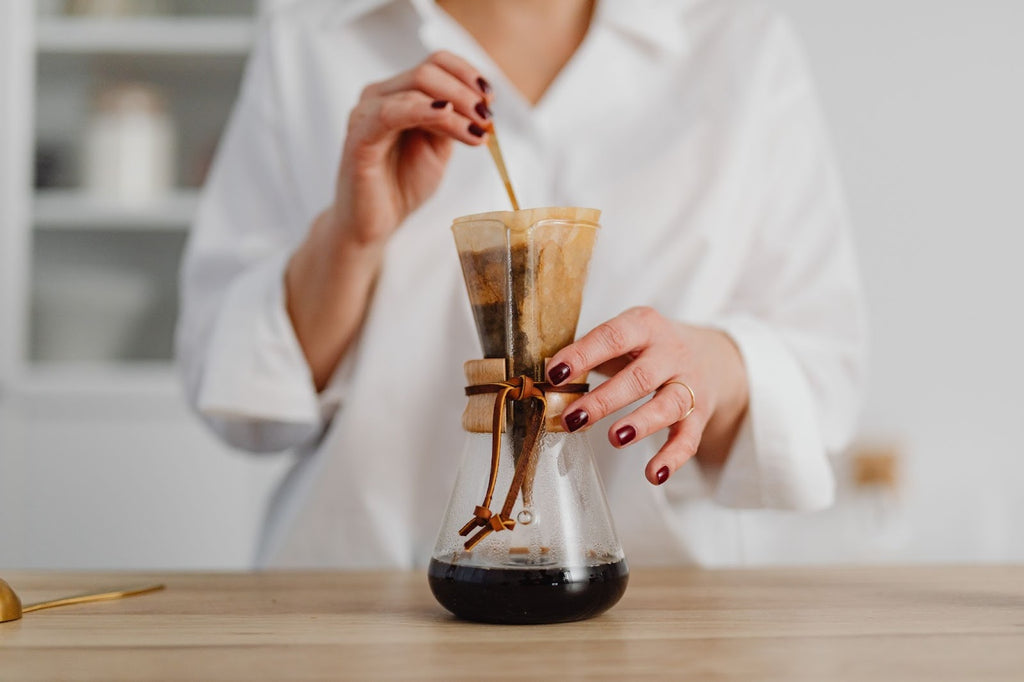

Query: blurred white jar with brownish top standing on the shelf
82;83;177;206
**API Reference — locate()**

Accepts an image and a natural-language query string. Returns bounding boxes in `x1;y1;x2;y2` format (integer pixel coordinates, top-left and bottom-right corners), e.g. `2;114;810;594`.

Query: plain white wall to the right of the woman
748;0;1024;561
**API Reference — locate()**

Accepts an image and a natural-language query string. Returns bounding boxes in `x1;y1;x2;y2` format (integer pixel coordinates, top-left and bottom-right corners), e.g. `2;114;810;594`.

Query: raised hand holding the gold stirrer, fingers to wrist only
332;52;492;246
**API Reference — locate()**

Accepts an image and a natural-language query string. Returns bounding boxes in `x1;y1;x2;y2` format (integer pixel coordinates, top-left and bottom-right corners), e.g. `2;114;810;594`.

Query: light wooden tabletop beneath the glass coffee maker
0;566;1024;682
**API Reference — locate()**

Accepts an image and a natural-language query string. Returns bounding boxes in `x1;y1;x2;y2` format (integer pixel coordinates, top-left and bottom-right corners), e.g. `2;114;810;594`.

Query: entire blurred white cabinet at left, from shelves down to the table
0;0;287;568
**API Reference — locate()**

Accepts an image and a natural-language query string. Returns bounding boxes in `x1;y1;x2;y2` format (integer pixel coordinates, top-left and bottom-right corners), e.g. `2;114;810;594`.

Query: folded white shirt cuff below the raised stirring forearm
197;246;326;424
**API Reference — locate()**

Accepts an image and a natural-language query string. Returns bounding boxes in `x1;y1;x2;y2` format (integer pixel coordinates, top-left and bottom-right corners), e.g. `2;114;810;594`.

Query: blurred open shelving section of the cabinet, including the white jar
27;2;255;370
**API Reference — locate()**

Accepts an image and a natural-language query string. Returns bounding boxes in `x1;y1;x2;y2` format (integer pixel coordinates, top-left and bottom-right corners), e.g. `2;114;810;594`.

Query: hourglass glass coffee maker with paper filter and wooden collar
429;207;629;624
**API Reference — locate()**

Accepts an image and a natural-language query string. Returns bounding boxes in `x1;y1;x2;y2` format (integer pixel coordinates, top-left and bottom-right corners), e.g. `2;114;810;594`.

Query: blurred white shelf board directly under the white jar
33;189;199;231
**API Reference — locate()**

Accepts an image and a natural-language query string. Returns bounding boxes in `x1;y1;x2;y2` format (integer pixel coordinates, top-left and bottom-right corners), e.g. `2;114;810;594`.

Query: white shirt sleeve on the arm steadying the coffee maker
708;17;866;510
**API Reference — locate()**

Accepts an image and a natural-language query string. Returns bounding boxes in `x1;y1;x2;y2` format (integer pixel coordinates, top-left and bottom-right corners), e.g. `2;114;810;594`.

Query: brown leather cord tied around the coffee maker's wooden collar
459;375;590;550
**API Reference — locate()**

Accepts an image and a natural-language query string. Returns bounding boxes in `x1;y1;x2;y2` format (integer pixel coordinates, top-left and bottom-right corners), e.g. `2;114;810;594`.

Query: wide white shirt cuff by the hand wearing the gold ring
709;316;836;511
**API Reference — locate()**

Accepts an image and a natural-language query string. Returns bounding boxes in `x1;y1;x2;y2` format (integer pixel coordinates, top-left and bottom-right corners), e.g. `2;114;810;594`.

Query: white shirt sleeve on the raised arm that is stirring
176;15;337;451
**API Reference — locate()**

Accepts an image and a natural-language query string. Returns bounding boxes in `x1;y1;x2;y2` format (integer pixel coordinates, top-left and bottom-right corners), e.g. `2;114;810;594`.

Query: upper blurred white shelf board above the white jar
36;16;256;56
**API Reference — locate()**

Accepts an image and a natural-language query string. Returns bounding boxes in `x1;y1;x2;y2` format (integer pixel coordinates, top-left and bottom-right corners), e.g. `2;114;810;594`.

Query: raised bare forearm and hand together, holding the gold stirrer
285;52;490;389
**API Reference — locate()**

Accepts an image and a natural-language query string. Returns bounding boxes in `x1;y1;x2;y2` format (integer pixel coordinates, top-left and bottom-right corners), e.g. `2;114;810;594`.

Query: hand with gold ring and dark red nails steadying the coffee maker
548;307;749;485
